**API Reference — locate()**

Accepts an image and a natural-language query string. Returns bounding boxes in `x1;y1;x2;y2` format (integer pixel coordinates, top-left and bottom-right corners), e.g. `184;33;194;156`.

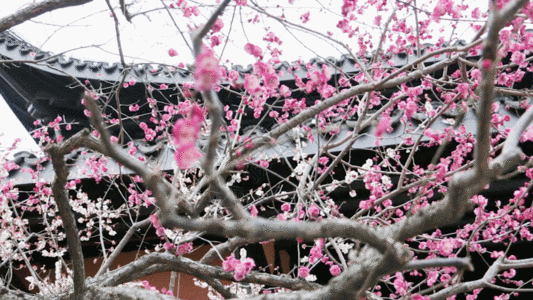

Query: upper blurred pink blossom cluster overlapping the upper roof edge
194;45;222;92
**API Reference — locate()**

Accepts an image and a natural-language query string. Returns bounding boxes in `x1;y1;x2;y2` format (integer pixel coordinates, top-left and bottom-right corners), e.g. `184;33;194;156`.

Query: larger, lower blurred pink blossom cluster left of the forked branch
172;105;204;170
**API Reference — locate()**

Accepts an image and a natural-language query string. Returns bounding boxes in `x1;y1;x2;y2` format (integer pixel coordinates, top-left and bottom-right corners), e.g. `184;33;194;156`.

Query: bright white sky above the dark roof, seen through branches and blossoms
0;0;482;158
